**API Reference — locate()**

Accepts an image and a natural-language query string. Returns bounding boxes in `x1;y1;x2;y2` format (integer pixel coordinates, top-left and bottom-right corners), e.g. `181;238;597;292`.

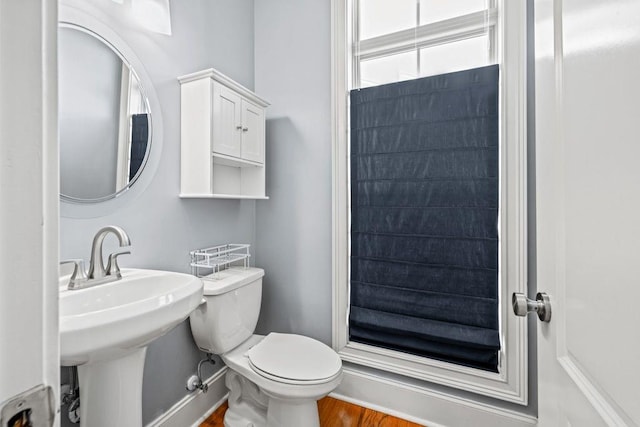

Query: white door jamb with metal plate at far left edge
0;0;60;427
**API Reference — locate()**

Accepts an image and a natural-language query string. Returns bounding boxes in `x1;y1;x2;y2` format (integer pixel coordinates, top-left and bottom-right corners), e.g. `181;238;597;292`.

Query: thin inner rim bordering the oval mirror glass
58;21;154;203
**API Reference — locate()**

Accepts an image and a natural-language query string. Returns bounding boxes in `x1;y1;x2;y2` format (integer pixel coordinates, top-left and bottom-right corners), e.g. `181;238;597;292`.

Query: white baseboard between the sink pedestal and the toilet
147;366;228;427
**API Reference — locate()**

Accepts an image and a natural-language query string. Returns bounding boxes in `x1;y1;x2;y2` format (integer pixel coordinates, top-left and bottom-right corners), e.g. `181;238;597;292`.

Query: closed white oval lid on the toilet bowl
247;332;342;382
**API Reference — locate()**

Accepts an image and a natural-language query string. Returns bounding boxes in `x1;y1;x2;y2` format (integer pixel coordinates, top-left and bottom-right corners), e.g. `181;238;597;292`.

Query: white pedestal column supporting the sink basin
78;346;147;427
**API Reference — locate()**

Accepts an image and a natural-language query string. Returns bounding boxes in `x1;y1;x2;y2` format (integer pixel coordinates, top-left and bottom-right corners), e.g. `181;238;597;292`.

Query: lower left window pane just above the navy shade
360;51;418;87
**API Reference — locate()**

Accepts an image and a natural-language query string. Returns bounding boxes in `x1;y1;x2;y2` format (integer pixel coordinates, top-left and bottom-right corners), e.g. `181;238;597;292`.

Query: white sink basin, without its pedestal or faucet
60;269;202;366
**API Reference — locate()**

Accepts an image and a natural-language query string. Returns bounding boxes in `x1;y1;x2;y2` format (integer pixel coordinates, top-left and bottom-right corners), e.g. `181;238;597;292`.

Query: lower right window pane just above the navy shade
420;34;490;77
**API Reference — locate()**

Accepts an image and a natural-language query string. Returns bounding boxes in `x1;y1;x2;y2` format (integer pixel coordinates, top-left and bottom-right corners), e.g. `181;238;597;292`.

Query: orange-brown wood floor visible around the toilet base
200;397;420;427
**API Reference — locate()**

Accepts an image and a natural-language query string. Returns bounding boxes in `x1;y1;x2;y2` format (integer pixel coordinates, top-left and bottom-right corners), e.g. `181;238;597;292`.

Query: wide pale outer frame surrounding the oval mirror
58;4;163;218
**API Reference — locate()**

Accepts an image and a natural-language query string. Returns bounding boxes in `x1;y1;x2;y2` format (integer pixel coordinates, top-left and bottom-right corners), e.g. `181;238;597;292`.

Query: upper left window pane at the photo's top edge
358;0;418;40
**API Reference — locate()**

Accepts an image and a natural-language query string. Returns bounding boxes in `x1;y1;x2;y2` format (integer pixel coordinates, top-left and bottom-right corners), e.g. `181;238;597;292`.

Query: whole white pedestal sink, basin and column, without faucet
60;269;202;427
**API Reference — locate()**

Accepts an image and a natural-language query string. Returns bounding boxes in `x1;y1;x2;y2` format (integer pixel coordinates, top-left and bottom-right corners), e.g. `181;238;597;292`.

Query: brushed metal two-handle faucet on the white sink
60;225;131;289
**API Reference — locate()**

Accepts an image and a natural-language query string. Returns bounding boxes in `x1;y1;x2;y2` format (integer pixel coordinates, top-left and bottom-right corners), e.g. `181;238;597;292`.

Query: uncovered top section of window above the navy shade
352;0;497;88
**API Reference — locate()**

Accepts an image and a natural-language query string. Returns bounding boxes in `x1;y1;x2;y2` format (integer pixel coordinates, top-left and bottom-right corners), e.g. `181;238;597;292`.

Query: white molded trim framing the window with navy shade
331;0;528;405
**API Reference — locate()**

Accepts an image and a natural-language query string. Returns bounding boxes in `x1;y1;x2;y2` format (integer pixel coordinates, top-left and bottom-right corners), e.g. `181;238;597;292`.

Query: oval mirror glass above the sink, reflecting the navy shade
58;23;152;203
